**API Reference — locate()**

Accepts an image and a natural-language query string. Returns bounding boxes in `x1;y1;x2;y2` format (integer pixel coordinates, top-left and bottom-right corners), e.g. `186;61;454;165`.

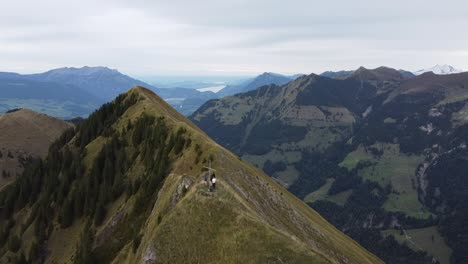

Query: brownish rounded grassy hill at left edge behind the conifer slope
0;109;72;190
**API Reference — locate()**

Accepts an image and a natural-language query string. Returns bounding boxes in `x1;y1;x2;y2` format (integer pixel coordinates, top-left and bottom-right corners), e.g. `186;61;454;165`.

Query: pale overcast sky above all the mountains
0;0;468;76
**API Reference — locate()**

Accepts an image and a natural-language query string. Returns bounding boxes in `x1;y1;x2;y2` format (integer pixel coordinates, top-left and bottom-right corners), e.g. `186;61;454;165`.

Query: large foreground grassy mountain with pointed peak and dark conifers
0;87;381;263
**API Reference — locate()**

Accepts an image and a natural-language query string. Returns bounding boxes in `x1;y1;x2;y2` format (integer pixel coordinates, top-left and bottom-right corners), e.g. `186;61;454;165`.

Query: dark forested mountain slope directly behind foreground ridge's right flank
191;68;397;186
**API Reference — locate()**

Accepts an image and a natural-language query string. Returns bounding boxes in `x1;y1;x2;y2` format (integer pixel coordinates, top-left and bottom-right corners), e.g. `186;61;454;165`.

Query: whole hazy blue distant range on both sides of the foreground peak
0;66;293;119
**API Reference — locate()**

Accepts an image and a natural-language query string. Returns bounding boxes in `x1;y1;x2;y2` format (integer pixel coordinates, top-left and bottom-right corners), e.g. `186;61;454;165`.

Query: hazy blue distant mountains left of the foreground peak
0;66;153;119
